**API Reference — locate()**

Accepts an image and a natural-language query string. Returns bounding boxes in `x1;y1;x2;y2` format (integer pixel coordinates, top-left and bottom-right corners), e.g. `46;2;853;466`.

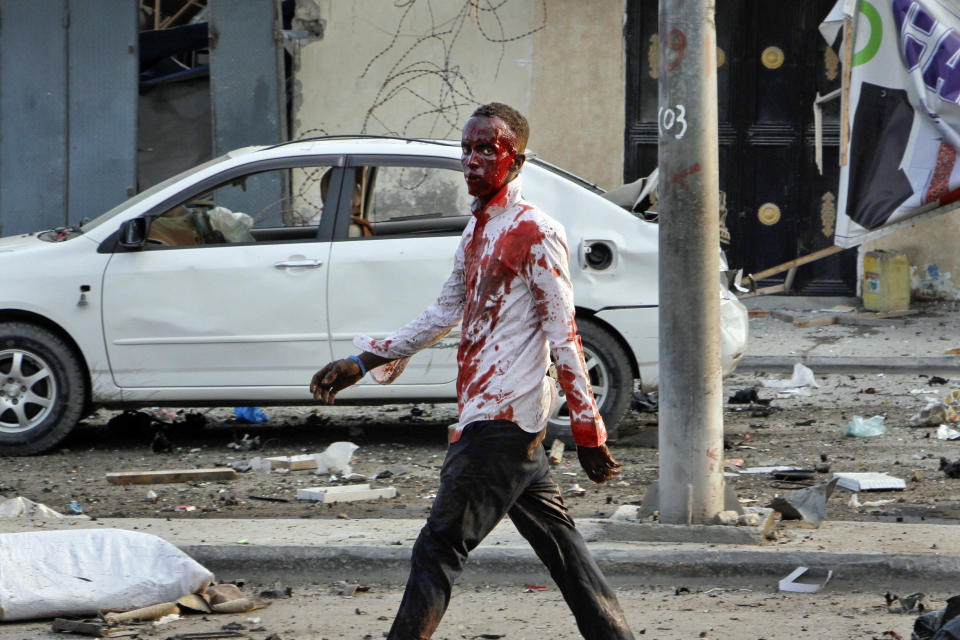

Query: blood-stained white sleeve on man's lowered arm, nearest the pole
523;225;607;447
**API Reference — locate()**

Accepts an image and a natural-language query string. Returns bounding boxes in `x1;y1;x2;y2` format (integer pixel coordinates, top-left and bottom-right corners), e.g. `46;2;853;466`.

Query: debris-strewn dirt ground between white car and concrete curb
0;373;960;522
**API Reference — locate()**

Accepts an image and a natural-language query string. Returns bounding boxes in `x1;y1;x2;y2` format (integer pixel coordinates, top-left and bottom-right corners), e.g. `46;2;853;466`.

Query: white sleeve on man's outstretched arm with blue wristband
353;234;466;384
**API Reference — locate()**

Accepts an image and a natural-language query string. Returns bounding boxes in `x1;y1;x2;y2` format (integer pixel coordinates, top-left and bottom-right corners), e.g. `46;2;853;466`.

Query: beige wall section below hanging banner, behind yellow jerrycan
858;211;960;300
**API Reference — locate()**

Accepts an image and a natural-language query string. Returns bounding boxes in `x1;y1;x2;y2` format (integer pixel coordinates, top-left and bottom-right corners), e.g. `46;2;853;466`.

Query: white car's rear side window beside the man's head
349;166;471;237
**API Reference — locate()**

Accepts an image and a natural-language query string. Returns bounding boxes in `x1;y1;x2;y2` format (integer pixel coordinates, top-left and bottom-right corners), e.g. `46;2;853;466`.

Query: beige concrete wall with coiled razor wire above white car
293;0;625;188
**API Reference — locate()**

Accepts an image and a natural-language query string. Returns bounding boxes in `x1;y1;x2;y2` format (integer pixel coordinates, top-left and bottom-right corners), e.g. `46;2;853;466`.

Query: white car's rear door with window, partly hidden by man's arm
327;156;470;397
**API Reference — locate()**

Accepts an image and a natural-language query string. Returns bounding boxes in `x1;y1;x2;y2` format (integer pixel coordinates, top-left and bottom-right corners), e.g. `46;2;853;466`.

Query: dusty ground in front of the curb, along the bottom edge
0;580;932;640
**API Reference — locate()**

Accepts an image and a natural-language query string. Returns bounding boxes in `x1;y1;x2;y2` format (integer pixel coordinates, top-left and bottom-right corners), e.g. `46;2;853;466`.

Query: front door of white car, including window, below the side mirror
102;157;342;392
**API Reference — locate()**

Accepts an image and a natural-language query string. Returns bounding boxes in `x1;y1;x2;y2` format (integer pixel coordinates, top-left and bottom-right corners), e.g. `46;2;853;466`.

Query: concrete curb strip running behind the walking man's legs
0;518;960;592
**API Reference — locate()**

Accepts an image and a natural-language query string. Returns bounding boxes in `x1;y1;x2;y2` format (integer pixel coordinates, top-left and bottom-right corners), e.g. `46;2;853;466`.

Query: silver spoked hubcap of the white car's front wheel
0;349;57;433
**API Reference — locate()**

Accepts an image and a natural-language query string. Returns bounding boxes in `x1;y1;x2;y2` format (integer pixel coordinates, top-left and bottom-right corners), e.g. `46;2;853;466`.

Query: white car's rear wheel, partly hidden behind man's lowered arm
544;318;633;447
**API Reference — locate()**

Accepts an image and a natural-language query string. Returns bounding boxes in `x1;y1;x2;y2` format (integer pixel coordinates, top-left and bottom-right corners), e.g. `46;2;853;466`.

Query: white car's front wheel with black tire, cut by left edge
0;322;87;456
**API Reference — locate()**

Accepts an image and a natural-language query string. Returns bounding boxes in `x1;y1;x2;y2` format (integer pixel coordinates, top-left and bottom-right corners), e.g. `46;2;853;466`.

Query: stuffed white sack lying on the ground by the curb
0;529;213;621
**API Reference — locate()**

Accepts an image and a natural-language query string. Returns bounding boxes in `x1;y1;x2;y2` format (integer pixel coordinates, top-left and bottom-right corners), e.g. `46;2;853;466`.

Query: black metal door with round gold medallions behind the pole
624;0;856;295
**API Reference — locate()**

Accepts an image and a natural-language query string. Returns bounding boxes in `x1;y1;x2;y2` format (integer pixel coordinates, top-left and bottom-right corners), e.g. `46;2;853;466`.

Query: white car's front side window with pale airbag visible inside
147;166;333;247
